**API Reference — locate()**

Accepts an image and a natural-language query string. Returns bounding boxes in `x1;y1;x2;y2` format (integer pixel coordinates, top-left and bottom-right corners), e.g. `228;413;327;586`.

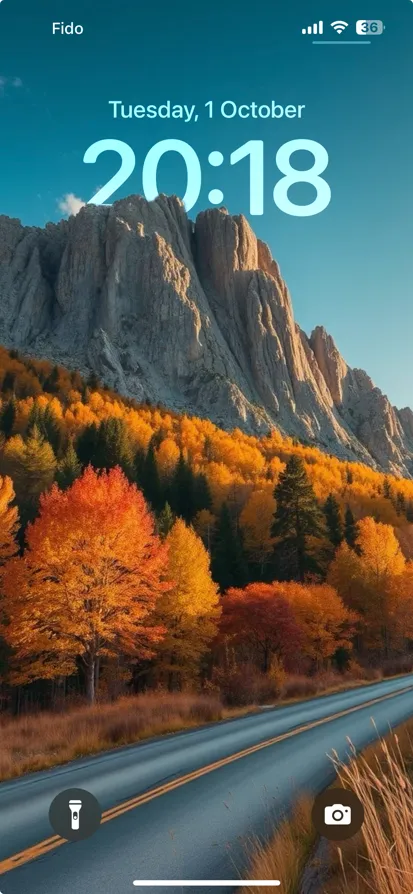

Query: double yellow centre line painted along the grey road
0;685;413;875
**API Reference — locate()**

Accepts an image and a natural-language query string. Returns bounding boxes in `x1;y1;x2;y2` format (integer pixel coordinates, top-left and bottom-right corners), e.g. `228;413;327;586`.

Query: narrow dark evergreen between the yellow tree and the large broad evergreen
211;503;248;591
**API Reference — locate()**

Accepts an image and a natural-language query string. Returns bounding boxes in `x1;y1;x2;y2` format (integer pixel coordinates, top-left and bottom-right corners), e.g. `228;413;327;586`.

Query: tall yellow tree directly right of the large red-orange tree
155;518;220;689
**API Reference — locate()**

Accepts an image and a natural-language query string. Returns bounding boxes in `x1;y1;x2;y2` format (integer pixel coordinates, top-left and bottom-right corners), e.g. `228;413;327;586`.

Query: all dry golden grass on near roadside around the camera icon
240;721;413;894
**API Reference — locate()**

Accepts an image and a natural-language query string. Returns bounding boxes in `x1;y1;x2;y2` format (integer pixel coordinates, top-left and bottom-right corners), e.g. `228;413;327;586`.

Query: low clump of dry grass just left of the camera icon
239;796;315;894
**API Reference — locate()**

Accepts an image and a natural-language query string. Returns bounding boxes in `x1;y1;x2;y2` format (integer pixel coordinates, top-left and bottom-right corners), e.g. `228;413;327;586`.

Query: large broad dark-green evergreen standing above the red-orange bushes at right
271;455;323;581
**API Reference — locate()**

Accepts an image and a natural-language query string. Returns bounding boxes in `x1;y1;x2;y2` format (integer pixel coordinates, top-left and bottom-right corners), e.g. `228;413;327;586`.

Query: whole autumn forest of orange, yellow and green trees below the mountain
0;349;413;714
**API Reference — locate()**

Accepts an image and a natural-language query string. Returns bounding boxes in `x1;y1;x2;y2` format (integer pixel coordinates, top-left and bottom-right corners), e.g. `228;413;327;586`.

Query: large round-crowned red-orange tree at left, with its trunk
4;467;170;702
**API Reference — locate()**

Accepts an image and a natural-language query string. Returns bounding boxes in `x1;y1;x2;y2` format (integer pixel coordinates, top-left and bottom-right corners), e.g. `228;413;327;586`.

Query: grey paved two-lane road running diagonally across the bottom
0;675;413;894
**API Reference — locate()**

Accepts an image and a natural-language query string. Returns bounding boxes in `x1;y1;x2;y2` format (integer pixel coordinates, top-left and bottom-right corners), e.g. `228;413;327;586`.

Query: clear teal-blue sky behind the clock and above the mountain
0;0;413;406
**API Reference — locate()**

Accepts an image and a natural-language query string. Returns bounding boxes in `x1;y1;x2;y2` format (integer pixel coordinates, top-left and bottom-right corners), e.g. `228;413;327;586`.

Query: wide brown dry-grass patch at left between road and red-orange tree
0;693;225;780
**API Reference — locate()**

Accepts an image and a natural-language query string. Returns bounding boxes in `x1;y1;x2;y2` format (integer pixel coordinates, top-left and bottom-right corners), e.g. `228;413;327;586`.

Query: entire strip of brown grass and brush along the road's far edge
0;673;402;782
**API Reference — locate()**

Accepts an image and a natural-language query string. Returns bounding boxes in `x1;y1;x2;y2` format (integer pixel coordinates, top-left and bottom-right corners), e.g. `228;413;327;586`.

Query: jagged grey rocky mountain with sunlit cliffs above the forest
0;196;413;476
